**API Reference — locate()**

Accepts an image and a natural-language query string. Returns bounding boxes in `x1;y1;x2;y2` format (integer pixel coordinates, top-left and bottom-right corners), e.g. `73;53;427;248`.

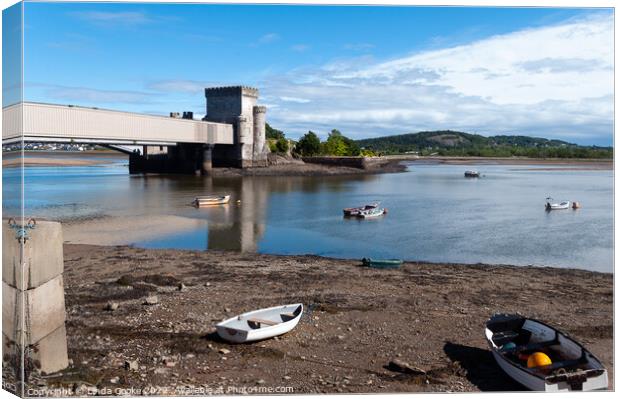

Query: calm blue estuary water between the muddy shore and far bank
3;160;613;272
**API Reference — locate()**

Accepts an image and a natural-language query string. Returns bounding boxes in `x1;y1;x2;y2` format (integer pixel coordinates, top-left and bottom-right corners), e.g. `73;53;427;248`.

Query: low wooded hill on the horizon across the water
356;130;613;158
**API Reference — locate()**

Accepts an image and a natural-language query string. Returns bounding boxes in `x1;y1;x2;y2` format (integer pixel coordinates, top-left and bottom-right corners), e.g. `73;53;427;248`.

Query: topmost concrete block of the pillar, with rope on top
2;220;64;290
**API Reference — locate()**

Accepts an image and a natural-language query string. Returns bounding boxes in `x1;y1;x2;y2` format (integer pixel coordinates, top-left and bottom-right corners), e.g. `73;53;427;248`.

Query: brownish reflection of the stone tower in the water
208;177;269;252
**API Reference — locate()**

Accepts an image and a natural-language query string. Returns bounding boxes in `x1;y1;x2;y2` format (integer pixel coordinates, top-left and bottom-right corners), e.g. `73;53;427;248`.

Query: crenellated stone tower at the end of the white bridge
204;86;268;168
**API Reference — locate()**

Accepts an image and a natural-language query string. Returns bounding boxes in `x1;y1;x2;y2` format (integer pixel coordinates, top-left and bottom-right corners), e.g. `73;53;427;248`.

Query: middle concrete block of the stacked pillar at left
2;275;66;345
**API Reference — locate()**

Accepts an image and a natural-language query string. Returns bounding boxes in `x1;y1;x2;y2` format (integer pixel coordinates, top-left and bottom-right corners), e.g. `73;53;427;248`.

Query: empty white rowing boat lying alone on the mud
215;303;304;343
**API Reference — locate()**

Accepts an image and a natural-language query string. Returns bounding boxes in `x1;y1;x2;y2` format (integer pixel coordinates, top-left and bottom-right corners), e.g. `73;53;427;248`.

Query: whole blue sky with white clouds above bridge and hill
6;2;614;145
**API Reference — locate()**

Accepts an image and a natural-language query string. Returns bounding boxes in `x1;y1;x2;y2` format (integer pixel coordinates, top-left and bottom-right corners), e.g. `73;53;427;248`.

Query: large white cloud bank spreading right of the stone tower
264;15;614;143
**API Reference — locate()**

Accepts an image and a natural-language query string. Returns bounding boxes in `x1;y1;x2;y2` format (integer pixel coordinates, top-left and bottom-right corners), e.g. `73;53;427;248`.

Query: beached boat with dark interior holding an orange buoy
485;314;608;392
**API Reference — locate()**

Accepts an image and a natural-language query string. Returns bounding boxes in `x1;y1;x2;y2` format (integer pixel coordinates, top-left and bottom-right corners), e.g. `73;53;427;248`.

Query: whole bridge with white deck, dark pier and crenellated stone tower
2;86;268;174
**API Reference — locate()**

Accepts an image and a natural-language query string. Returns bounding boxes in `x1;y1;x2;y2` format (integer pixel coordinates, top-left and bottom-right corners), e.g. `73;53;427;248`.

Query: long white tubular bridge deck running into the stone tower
2;102;234;145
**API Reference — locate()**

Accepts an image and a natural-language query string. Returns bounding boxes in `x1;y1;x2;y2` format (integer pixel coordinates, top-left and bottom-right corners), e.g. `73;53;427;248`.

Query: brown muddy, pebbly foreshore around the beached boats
10;244;614;396
